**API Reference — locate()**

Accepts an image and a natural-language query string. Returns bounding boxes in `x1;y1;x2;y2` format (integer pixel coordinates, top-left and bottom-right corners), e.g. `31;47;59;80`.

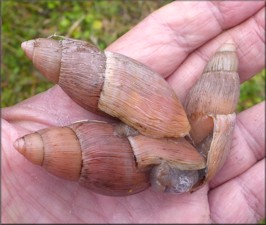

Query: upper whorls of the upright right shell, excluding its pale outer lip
185;43;240;144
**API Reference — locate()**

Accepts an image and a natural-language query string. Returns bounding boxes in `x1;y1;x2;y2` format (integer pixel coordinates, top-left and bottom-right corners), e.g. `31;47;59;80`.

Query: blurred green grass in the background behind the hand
1;0;265;111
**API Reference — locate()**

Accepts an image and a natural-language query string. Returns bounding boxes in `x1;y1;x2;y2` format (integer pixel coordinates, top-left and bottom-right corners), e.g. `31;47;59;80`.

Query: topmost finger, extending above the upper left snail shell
108;1;264;77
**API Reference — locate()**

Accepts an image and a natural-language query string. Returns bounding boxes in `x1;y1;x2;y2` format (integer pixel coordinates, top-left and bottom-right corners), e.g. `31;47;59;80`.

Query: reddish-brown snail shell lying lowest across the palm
14;121;206;196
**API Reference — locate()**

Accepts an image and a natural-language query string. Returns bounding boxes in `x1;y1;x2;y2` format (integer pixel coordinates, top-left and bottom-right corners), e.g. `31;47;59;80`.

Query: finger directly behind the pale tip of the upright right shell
168;8;265;101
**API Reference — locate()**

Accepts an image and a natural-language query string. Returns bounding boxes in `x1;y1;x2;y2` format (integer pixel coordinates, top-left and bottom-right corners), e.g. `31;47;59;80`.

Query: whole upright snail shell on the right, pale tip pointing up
185;43;240;190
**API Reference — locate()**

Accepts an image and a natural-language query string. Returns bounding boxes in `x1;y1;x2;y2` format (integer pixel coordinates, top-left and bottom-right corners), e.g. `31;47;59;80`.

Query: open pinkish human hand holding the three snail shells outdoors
2;1;265;223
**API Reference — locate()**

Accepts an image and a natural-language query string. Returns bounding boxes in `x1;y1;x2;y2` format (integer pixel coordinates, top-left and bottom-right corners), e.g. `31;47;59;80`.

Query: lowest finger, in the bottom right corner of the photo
209;159;265;224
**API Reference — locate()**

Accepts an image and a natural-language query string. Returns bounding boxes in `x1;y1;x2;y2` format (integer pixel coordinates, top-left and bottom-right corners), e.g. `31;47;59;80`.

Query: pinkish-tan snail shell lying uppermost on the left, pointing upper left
22;38;190;138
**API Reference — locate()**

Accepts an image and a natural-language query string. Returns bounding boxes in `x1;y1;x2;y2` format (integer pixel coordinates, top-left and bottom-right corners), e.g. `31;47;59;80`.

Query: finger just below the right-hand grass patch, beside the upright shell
210;102;265;188
